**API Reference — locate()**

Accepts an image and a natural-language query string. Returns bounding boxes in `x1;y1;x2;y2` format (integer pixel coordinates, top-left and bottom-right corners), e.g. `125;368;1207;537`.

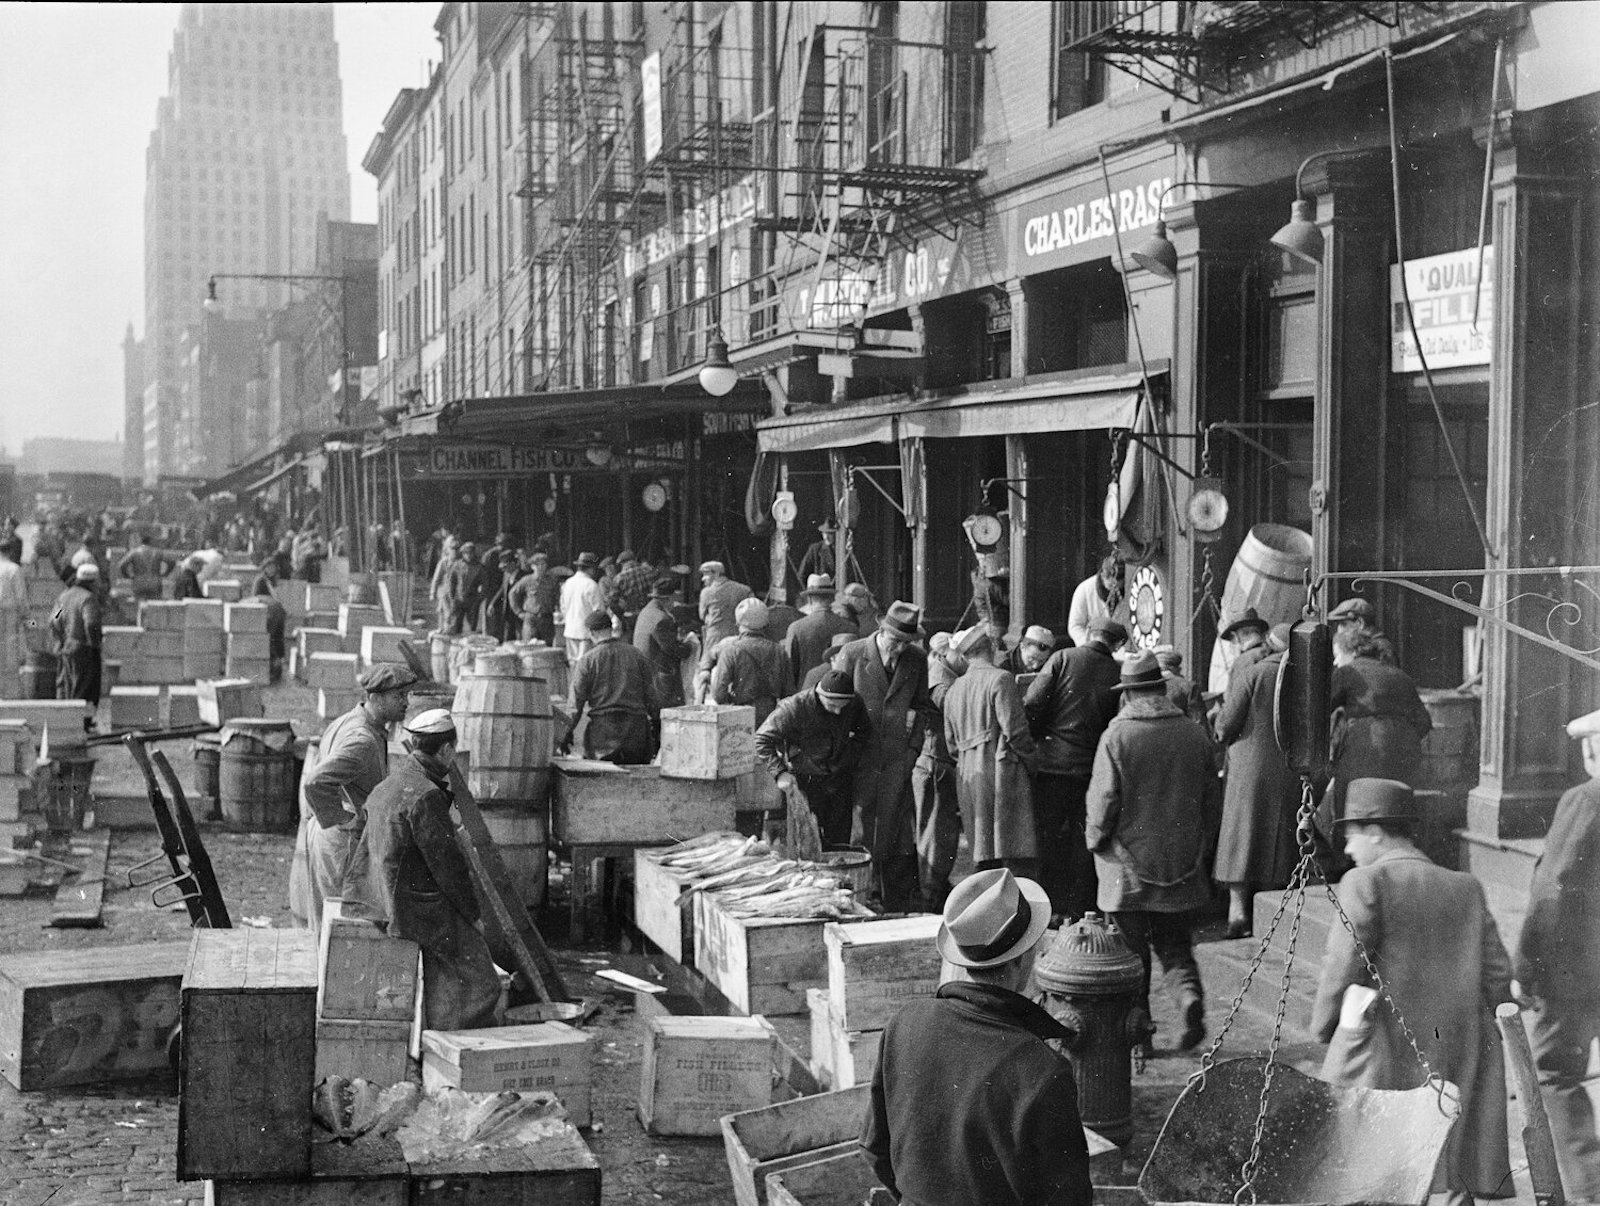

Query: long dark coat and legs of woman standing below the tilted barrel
1213;639;1299;937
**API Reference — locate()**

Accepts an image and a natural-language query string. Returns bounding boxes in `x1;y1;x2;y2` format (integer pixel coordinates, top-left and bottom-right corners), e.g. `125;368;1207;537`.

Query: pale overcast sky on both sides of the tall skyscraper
0;0;438;456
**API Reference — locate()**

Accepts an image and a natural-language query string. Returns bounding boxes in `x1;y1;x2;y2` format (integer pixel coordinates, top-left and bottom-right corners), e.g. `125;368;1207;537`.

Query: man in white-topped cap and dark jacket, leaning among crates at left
365;707;501;1030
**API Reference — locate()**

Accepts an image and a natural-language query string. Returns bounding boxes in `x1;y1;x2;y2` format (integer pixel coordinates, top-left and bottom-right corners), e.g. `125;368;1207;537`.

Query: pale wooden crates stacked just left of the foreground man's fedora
806;913;941;1089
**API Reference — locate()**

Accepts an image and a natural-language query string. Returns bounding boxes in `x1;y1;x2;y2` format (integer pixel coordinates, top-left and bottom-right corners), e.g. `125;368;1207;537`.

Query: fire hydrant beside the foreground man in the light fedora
1034;913;1154;1147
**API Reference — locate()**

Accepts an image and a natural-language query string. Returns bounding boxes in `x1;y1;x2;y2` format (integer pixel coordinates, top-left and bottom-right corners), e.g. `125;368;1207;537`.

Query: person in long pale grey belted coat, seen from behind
944;624;1038;875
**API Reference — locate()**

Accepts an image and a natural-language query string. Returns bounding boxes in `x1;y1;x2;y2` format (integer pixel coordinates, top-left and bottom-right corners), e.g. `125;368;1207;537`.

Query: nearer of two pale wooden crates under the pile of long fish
694;893;870;1014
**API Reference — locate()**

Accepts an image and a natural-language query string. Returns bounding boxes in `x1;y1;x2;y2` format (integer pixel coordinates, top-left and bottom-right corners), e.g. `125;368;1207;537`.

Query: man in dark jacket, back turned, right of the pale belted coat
1022;616;1128;921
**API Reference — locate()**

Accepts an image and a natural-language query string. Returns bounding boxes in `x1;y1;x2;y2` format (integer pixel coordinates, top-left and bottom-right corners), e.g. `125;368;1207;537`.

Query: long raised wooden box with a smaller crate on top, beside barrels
550;758;734;846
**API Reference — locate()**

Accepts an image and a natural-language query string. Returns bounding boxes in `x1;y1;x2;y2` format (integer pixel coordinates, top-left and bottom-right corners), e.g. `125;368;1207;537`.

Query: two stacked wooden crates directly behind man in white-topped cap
317;901;422;1084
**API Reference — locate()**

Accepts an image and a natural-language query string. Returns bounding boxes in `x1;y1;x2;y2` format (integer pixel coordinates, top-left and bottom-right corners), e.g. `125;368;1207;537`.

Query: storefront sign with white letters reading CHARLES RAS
1016;173;1173;277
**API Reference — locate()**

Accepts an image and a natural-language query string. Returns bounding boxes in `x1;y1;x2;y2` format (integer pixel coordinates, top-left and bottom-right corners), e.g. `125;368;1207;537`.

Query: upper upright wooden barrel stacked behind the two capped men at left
451;673;555;803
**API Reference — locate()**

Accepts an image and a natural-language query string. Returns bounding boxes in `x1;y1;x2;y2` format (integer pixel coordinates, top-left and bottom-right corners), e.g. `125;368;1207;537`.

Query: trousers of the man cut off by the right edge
1528;1001;1600;1201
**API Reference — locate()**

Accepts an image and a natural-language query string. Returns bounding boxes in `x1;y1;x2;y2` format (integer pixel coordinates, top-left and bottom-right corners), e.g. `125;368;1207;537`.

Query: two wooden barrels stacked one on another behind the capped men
454;658;555;907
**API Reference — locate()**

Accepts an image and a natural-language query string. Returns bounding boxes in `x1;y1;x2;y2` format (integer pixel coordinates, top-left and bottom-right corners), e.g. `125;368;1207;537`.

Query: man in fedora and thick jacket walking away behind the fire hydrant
1083;649;1221;1051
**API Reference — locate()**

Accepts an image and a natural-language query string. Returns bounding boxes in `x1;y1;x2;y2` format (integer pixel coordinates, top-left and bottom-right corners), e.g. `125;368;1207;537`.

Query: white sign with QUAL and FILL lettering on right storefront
1389;246;1494;373
